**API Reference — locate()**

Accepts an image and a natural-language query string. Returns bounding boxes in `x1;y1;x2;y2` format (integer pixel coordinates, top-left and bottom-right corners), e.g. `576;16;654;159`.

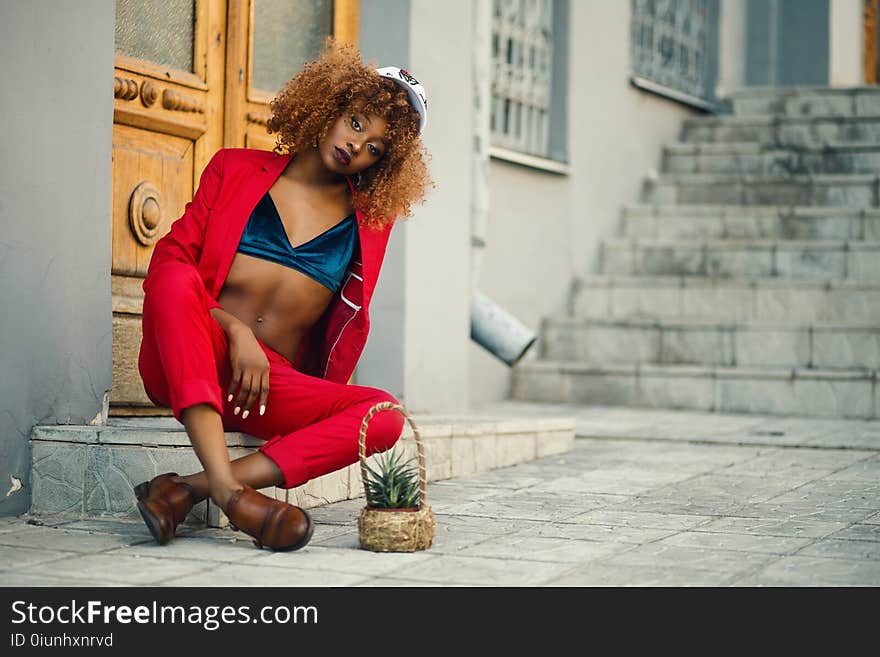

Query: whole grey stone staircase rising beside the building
512;88;880;418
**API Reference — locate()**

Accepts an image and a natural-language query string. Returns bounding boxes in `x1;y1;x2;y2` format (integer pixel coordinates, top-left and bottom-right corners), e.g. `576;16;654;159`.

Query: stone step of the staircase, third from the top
662;141;880;175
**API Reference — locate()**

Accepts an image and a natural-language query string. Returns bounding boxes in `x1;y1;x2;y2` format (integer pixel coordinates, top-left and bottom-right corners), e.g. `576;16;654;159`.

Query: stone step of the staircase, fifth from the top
622;204;880;241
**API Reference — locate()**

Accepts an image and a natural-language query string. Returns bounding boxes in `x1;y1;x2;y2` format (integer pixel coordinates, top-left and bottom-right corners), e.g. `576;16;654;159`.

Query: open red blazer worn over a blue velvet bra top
143;148;391;383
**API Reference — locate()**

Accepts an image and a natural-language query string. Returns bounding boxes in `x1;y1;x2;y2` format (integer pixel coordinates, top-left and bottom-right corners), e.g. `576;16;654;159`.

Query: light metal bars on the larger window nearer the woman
490;0;553;157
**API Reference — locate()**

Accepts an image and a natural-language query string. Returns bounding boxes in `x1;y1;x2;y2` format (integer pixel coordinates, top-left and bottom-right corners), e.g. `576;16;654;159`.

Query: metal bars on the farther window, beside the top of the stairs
631;0;710;99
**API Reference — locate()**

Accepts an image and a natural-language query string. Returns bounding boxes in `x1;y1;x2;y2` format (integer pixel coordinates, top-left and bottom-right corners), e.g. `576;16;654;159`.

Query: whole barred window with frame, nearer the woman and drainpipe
490;0;568;170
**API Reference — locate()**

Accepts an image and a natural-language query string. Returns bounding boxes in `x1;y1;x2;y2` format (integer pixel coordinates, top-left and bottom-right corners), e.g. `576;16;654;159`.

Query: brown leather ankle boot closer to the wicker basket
226;485;315;551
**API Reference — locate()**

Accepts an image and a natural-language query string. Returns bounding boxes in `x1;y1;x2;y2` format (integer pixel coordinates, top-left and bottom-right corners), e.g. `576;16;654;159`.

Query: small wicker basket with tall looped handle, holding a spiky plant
358;402;435;552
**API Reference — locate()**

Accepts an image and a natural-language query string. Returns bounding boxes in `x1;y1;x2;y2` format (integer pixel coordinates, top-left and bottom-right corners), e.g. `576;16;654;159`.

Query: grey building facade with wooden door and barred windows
0;0;877;515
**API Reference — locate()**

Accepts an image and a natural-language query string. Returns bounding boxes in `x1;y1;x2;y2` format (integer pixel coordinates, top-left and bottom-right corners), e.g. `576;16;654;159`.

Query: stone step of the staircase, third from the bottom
573;275;880;323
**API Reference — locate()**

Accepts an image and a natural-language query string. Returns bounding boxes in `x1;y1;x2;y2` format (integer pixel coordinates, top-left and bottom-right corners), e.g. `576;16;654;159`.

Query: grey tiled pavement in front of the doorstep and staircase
0;404;880;587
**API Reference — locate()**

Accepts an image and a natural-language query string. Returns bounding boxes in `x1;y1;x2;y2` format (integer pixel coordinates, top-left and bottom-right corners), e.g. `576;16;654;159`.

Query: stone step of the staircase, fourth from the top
642;173;880;207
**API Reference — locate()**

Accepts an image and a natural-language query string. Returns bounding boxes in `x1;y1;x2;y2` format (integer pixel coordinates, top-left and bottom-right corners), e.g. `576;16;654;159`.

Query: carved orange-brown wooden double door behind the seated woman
110;0;358;415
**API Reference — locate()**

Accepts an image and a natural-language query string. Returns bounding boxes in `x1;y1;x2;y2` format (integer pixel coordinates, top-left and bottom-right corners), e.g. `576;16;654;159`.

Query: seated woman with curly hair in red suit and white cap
135;39;432;550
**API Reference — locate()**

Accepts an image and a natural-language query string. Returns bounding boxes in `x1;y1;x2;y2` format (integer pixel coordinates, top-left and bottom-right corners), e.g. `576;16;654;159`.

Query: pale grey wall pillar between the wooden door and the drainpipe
355;0;474;412
